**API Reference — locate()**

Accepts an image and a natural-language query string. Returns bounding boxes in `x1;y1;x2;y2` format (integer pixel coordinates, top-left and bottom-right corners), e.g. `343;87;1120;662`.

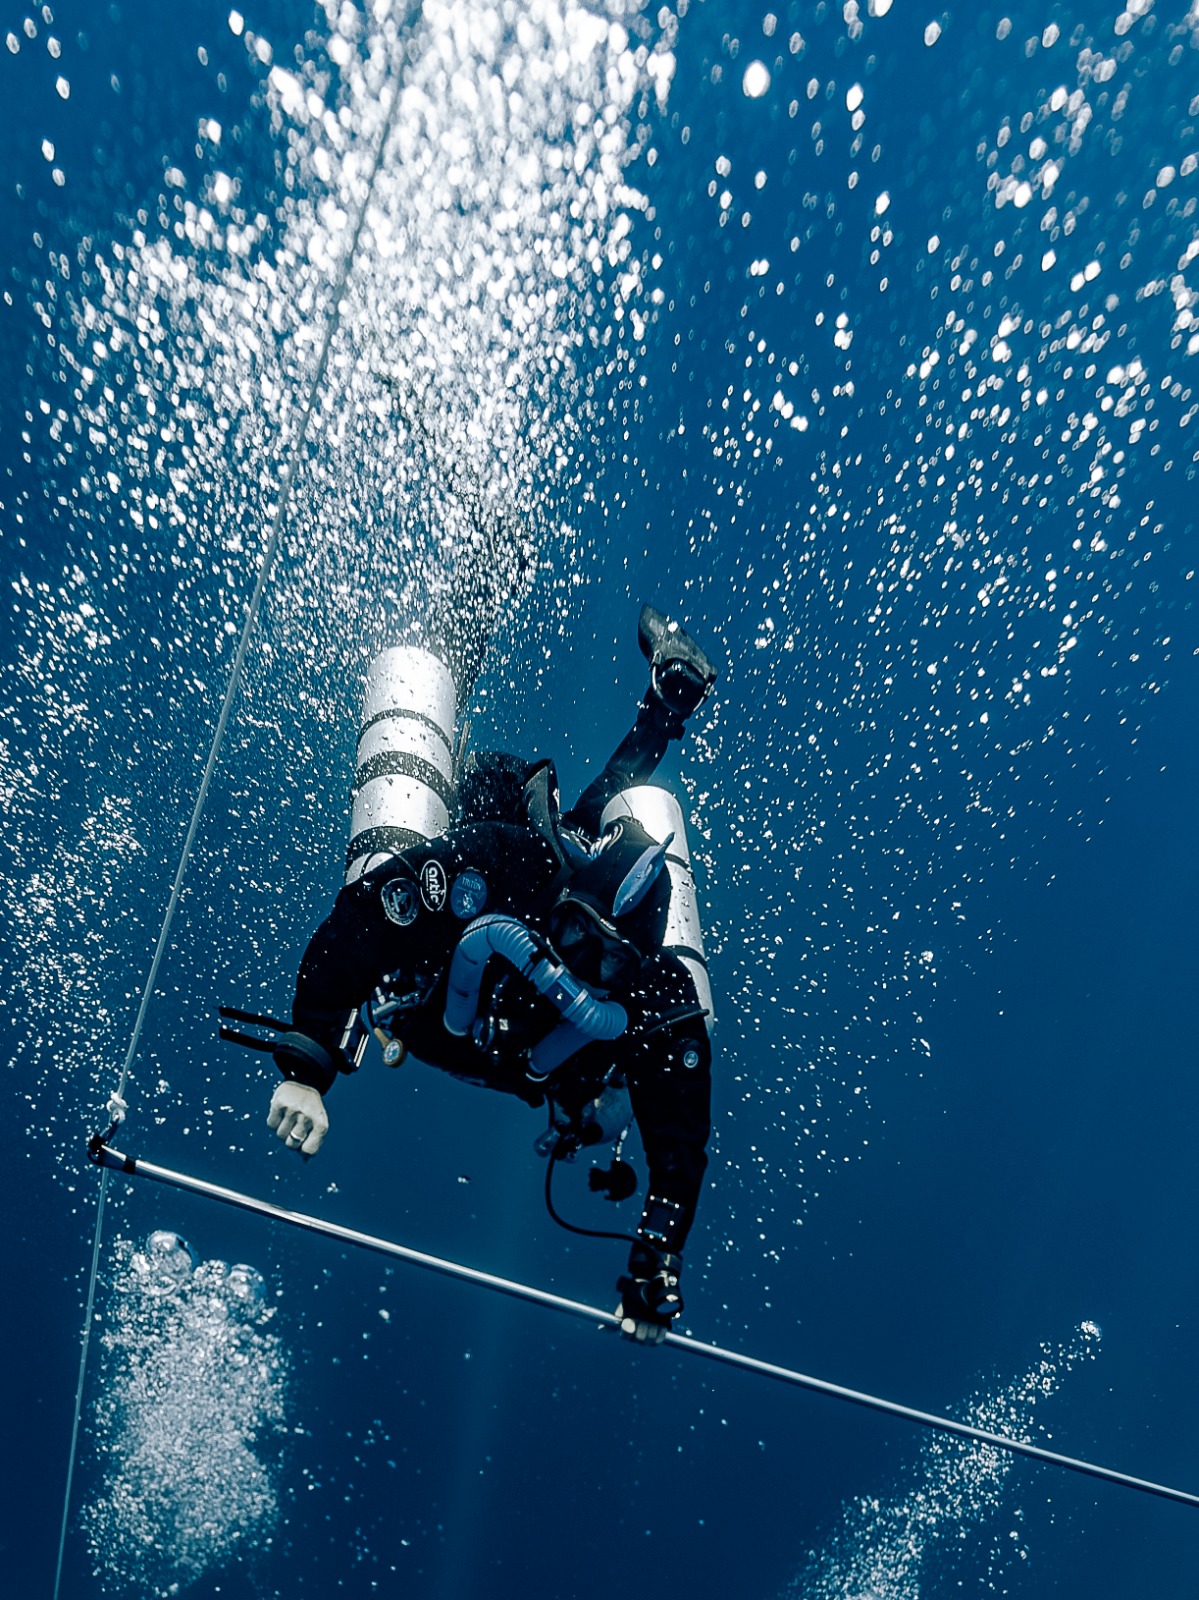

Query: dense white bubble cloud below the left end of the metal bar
83;1230;287;1595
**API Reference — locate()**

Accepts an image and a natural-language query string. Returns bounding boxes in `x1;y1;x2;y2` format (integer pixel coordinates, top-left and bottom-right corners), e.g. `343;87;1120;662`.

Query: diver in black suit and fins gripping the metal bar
269;606;716;1342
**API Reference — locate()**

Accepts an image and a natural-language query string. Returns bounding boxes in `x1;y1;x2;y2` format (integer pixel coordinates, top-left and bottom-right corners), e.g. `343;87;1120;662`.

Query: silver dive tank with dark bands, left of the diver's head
346;645;458;883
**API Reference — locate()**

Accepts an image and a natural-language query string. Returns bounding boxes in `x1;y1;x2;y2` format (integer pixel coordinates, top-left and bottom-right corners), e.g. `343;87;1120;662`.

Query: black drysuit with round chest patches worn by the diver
275;720;711;1253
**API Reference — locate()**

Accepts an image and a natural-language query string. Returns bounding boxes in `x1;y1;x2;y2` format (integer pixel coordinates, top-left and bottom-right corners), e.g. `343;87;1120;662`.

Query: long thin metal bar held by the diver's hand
90;1139;1199;1506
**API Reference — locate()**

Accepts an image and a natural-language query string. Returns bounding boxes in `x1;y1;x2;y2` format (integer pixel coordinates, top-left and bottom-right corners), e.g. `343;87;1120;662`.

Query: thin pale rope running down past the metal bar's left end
54;40;421;1600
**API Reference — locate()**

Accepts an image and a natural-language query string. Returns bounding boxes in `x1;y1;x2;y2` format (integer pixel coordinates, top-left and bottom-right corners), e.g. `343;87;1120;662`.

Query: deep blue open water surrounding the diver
0;0;1199;1600
